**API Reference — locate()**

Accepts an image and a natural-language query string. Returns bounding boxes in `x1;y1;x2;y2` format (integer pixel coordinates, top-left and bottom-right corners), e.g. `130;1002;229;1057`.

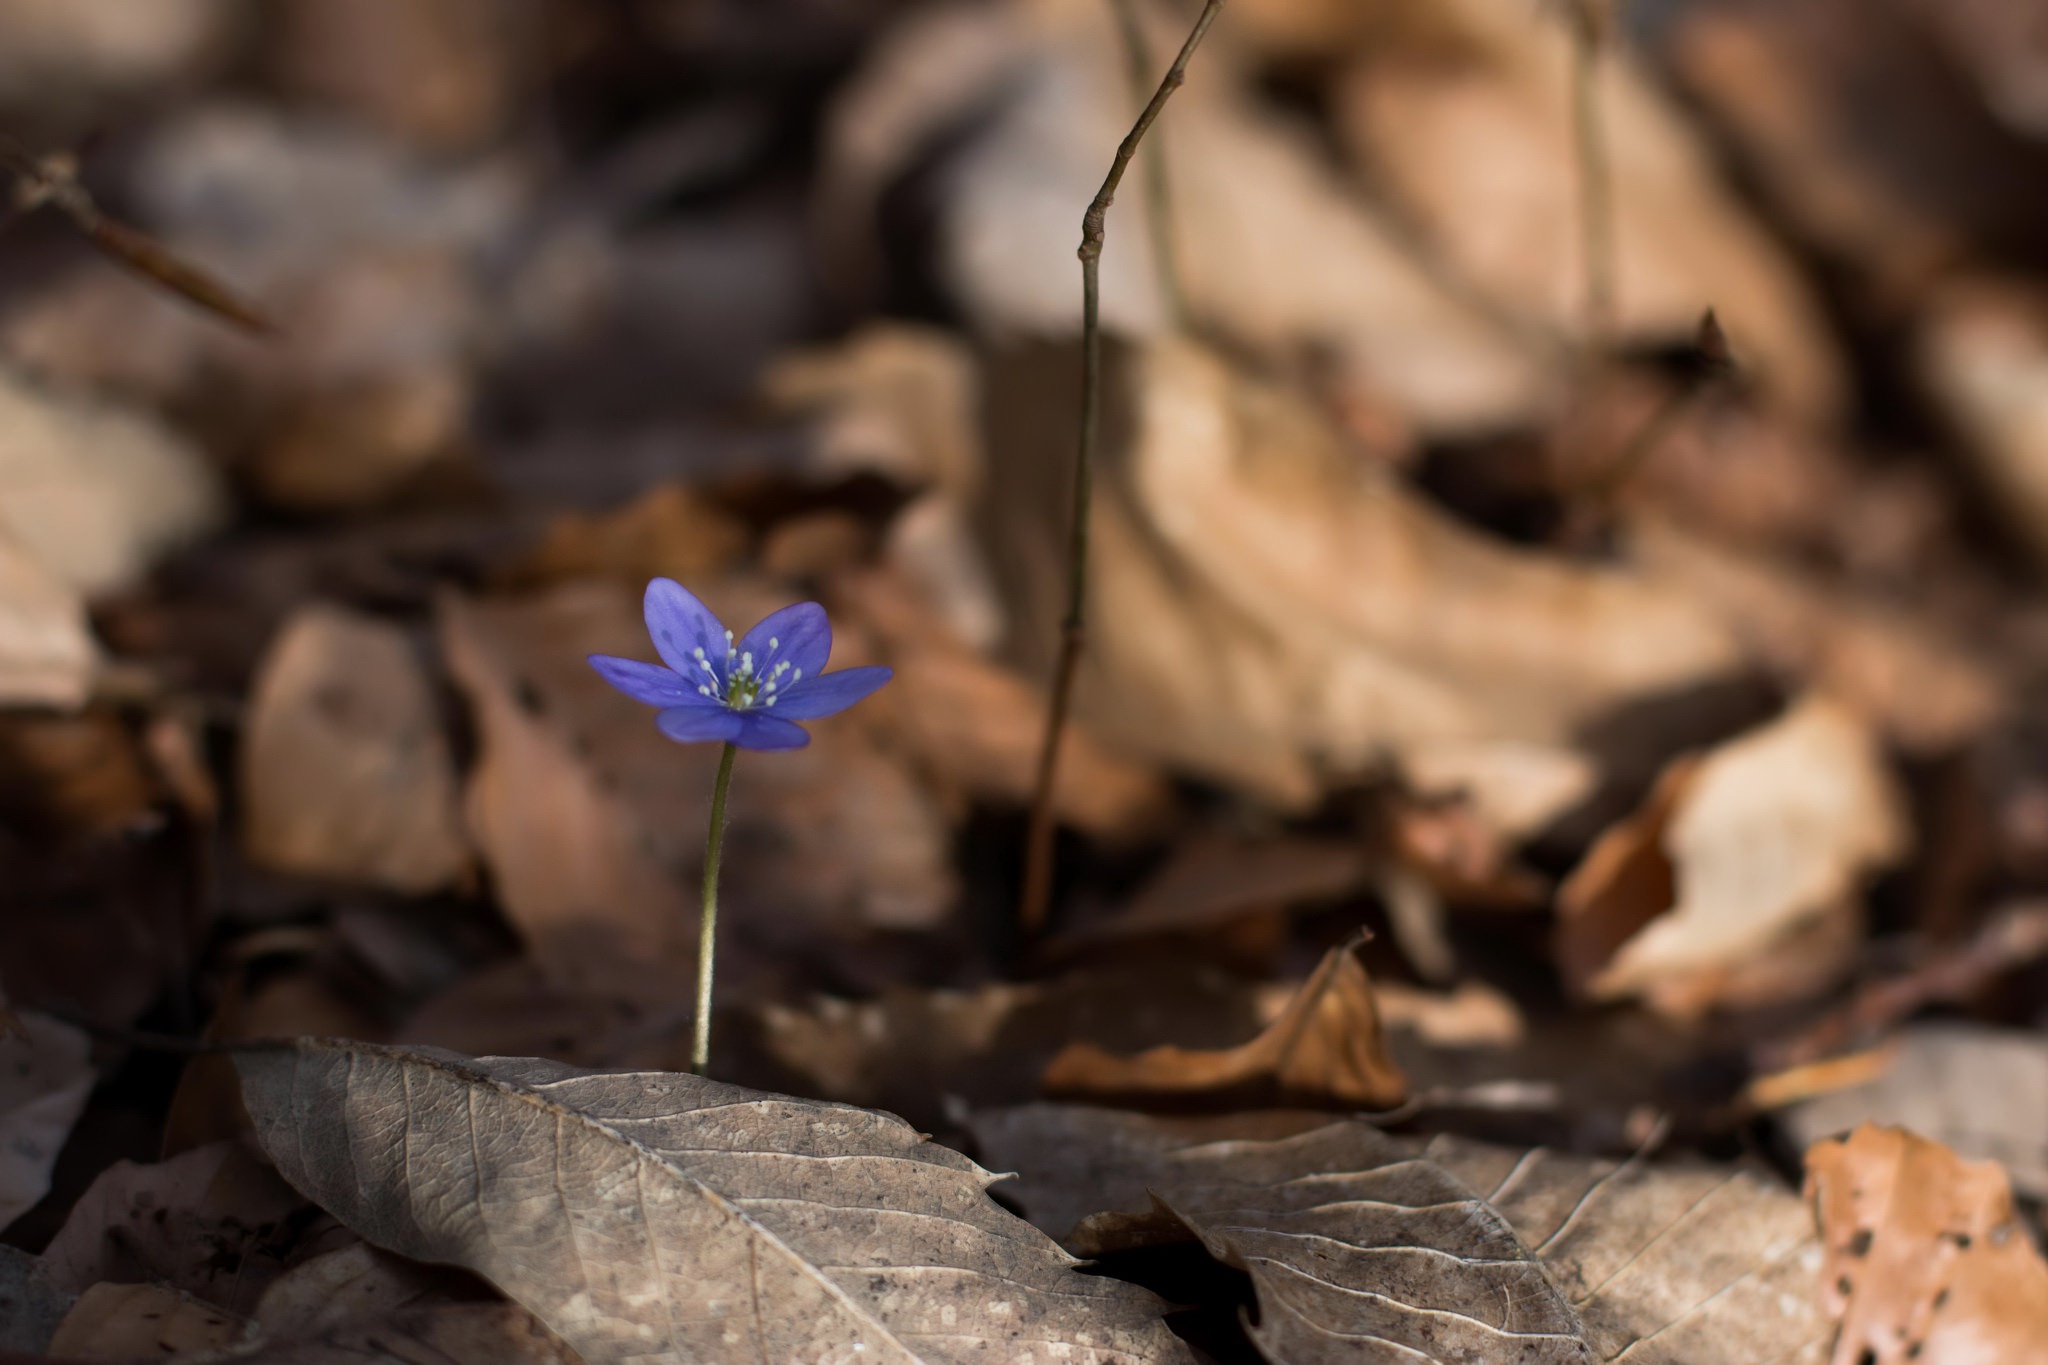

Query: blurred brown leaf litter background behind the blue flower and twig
12;0;2048;1246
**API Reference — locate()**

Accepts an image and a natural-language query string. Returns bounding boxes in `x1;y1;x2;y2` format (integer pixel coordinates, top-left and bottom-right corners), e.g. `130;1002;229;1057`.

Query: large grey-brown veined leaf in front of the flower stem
238;1040;1190;1365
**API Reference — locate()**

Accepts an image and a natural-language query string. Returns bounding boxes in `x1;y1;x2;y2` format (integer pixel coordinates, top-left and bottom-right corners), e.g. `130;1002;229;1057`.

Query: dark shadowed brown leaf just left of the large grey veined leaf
43;1142;305;1314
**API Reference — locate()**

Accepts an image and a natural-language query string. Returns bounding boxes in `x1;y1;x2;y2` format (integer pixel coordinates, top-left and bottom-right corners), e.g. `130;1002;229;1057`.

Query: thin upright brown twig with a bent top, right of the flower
1018;0;1223;931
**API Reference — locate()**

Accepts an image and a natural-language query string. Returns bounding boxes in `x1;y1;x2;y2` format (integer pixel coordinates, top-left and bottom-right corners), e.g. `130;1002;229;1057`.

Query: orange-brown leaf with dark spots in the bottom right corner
1806;1124;2048;1365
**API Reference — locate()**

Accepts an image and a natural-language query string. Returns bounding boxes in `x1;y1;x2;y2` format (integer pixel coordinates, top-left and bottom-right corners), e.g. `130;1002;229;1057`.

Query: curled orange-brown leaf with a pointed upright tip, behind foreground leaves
1042;941;1407;1109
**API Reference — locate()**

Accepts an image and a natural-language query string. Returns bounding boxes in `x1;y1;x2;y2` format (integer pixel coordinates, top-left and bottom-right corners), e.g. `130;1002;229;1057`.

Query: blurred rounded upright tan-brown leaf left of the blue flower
242;606;469;894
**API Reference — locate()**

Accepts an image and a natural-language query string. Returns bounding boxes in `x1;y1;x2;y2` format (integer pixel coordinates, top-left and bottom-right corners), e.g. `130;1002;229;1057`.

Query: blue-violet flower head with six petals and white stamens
590;579;891;749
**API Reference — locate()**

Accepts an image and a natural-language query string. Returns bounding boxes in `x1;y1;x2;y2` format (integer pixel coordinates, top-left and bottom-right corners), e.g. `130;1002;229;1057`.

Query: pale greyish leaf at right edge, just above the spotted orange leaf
1778;1019;2048;1197
